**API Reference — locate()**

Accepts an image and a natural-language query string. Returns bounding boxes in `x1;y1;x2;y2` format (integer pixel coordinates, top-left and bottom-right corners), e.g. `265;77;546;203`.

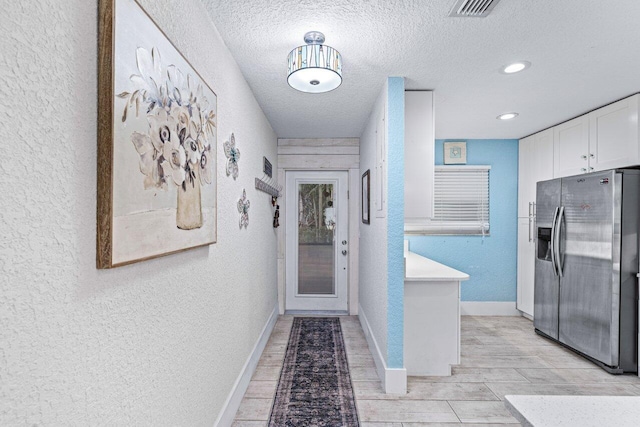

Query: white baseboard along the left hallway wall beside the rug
213;305;278;427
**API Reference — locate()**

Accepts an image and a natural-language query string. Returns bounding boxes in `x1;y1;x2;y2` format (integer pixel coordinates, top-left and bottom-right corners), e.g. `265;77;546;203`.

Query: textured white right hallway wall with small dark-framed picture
359;81;387;363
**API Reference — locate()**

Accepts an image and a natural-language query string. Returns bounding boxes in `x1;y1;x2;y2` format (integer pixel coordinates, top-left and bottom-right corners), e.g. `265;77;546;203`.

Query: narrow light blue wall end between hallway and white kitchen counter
387;77;404;368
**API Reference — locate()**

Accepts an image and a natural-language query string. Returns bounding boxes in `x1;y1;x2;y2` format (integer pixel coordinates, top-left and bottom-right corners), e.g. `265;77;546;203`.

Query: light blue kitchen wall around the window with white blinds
407;139;518;301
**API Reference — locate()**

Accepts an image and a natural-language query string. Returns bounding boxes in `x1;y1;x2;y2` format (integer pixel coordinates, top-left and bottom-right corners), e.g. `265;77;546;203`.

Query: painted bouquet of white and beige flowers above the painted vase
117;47;216;191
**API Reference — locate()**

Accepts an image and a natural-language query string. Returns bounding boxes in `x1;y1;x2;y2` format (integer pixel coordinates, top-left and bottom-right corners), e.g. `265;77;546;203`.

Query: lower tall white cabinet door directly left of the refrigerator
516;217;536;317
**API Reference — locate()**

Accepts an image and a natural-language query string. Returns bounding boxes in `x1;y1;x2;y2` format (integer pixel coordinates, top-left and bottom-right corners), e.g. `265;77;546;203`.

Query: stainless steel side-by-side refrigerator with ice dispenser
533;170;640;373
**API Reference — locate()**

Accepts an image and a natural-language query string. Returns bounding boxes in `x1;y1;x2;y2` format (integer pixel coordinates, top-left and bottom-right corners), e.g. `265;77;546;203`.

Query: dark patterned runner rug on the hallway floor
269;317;360;427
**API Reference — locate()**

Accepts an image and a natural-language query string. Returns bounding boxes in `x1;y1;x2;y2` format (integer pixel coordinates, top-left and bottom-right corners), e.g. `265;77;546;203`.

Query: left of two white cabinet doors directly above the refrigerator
553;115;589;178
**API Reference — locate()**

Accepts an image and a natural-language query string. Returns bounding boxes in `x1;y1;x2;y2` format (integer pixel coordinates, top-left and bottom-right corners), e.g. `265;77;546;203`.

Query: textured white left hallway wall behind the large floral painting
0;0;277;426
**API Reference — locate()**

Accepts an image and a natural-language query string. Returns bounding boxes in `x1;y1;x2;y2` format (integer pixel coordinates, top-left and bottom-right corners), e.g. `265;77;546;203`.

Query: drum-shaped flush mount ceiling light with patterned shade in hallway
287;31;342;93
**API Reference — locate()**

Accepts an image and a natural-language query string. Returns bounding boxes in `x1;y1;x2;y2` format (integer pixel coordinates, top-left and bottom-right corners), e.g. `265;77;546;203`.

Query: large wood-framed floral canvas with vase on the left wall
96;0;217;268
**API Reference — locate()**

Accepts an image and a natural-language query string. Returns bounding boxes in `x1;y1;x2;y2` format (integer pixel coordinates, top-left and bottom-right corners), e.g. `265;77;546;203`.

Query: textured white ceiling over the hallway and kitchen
202;0;640;138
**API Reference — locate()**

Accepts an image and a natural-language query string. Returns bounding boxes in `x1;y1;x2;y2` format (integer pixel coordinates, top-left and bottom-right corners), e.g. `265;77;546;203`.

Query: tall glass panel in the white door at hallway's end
298;184;336;295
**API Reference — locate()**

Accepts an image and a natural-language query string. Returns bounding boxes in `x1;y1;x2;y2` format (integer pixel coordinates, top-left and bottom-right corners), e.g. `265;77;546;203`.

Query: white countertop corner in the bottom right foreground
504;396;640;427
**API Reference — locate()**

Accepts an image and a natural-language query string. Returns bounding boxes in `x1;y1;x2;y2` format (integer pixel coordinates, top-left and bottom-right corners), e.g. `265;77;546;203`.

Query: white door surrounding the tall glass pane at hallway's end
284;171;350;312
